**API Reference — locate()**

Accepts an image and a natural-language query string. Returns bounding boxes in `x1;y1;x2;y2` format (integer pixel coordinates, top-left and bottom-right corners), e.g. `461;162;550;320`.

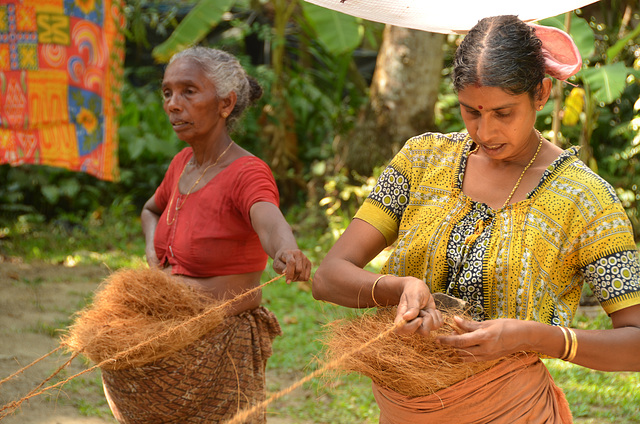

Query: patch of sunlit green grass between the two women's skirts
263;270;378;424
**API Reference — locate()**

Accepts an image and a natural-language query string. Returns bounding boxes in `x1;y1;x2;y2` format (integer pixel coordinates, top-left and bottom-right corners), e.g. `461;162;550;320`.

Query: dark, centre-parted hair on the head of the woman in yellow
453;15;545;100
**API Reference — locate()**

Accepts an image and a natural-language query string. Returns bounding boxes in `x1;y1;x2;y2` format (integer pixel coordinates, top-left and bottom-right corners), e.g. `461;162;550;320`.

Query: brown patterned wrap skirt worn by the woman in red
102;307;282;424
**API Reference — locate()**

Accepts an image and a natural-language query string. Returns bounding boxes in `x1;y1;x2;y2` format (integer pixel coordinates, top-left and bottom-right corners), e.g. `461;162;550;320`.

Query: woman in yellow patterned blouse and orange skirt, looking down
313;16;640;423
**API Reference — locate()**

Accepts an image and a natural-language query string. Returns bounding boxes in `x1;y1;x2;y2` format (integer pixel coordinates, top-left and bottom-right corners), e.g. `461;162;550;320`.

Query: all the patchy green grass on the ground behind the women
0;211;640;424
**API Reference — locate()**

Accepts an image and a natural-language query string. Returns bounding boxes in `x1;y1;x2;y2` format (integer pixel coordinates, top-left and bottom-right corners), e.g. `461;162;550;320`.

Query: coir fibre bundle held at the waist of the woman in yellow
324;307;498;397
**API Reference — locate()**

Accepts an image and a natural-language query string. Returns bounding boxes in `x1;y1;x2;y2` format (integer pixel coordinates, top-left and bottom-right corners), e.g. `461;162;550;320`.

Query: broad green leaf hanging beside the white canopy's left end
302;2;363;55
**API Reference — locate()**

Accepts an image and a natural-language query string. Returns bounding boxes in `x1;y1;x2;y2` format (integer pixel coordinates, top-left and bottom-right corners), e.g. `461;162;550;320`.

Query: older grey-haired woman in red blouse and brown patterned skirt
103;47;311;423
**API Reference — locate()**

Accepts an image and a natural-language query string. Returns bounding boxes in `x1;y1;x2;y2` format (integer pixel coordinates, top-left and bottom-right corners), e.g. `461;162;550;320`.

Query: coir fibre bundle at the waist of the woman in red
62;269;224;370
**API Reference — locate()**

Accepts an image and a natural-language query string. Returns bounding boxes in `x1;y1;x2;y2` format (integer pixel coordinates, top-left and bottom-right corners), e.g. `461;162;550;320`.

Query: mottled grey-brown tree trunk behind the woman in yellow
336;25;445;175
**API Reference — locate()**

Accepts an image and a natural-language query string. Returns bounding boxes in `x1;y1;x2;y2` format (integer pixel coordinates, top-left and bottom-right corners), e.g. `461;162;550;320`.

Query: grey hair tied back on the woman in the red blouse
169;46;262;127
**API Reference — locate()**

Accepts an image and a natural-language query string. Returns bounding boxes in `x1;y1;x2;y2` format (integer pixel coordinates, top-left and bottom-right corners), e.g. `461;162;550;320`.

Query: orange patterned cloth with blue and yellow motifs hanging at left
0;0;125;181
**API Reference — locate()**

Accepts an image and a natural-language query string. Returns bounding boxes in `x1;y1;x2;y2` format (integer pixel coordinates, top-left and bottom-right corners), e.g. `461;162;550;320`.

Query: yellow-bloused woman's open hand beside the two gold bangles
436;316;529;362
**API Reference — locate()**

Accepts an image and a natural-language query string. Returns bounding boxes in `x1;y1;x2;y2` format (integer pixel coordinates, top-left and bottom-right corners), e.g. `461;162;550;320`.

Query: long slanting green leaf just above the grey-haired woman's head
152;0;236;62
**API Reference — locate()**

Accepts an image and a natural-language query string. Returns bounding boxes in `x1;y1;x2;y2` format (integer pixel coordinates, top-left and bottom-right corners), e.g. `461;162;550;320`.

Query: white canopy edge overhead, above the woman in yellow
306;0;598;34
